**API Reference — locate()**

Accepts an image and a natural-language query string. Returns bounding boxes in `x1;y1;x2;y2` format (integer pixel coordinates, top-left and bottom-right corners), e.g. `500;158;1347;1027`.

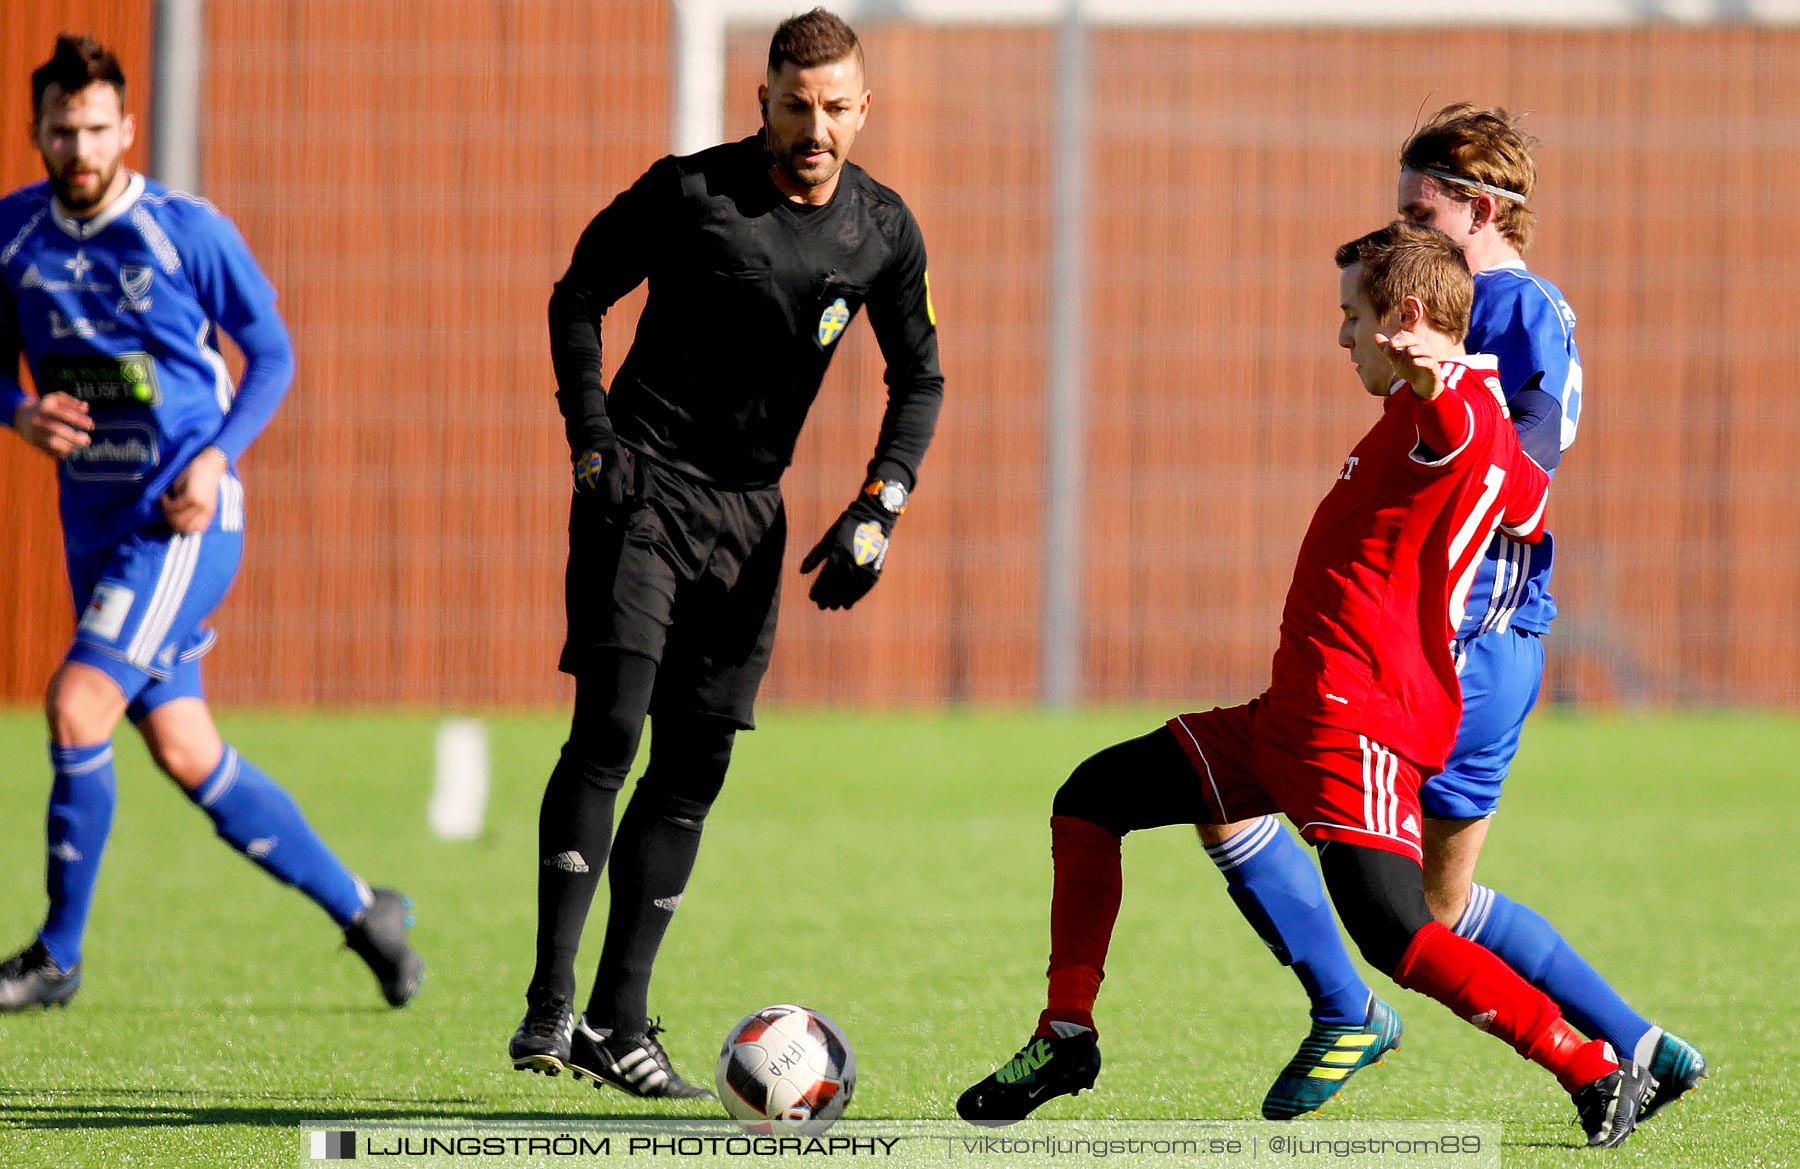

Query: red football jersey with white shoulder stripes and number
1267;353;1550;773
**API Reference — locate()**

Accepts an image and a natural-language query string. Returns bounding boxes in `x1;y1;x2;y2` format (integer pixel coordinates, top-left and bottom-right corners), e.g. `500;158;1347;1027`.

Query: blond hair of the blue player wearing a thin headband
1400;101;1541;252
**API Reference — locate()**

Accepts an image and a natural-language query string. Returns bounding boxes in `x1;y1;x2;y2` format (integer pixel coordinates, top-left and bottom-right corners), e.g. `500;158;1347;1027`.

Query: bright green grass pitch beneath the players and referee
0;710;1800;1169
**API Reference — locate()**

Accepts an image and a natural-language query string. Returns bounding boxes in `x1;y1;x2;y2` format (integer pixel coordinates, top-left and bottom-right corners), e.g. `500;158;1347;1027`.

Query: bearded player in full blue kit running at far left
0;36;421;1010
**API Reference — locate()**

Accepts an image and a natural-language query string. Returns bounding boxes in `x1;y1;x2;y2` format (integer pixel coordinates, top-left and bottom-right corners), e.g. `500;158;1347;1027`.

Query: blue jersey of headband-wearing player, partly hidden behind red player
1456;263;1582;638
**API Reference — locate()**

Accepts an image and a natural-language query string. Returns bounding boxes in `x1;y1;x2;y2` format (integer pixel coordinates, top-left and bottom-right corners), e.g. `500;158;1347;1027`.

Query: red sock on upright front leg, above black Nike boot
1037;816;1123;1036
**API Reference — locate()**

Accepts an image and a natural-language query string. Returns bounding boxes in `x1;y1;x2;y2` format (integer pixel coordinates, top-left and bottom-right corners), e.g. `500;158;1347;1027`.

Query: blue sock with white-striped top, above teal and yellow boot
1206;816;1373;1025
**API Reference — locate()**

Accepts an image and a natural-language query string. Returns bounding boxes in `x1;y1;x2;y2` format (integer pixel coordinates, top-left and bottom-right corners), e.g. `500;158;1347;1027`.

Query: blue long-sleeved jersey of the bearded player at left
0;173;293;558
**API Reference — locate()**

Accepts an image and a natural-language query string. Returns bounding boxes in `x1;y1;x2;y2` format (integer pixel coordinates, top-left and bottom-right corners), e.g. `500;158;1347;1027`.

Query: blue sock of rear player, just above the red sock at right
1456;884;1651;1057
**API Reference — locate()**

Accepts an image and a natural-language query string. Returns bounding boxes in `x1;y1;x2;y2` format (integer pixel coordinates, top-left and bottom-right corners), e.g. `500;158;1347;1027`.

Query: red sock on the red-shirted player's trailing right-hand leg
1393;922;1618;1092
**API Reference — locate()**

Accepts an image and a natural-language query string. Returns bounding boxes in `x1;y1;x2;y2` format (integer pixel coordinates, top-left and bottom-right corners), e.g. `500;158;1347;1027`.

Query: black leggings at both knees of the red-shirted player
1051;728;1431;974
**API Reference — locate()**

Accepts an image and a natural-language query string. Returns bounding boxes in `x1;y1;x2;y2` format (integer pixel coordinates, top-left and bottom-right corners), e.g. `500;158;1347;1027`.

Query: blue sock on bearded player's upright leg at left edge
38;742;119;971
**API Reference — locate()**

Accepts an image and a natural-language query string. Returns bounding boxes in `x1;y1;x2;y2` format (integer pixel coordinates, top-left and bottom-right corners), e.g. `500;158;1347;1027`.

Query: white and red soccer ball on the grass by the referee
713;1005;857;1137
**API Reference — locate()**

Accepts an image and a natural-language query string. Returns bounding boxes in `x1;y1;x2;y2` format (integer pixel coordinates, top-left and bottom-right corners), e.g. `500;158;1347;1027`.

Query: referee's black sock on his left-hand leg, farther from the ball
526;654;657;1001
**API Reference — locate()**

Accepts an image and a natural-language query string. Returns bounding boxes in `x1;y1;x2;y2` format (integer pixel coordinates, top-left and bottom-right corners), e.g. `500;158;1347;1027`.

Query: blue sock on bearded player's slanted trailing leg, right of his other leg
187;746;367;926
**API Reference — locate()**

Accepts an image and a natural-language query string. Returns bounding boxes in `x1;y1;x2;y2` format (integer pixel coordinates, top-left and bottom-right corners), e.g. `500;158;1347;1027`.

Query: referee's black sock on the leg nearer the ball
587;717;736;1036
